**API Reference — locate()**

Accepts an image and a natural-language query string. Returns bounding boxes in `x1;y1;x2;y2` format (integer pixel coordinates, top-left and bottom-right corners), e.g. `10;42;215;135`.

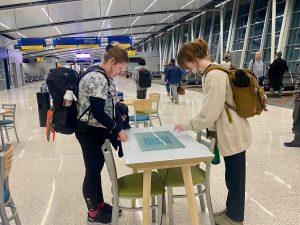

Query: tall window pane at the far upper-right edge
285;1;300;72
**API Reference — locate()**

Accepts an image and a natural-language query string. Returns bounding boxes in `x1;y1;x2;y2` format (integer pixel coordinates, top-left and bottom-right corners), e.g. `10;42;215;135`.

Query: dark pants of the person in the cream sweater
224;151;246;222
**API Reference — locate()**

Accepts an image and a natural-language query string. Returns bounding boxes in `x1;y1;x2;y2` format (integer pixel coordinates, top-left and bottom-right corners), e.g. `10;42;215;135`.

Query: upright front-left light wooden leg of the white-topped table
142;170;152;225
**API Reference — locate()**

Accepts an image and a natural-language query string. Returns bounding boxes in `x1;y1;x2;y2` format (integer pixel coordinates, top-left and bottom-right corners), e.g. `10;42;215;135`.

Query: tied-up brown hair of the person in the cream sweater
177;39;208;68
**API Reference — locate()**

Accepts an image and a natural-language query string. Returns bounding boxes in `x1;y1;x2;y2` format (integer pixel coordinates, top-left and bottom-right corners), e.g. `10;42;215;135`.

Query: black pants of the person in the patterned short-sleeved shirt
75;127;108;211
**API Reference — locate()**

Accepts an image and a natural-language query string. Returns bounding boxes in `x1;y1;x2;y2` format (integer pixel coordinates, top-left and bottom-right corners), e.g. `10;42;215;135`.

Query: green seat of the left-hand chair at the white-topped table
118;172;165;198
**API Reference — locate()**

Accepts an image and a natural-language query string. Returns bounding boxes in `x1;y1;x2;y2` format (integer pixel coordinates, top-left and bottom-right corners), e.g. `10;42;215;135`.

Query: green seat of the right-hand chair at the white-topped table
158;166;205;187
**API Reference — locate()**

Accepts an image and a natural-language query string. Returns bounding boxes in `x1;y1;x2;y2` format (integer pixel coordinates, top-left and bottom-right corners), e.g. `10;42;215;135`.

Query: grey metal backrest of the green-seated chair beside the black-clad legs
102;139;119;196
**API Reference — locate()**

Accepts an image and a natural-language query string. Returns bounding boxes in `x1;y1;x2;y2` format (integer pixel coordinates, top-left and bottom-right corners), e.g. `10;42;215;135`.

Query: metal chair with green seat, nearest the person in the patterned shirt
102;140;165;225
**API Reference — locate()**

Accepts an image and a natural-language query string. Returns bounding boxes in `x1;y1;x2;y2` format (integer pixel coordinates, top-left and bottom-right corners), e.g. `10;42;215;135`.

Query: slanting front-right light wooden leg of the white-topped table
181;166;199;225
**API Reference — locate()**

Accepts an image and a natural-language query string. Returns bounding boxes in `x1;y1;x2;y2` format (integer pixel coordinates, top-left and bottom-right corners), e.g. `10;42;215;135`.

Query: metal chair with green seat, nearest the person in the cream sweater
158;132;216;225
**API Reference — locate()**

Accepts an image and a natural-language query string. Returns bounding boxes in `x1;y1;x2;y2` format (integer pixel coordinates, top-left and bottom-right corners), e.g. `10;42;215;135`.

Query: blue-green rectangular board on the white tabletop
135;131;185;152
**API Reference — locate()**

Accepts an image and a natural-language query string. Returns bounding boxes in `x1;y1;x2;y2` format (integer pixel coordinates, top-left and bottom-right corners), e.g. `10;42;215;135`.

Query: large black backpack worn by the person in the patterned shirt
46;66;110;134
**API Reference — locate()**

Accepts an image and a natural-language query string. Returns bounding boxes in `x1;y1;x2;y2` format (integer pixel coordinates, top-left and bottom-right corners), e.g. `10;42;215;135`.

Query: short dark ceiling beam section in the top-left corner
0;0;83;11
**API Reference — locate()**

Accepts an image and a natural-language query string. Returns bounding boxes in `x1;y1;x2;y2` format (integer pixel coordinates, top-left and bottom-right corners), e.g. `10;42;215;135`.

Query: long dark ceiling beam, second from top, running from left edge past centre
0;9;203;34
